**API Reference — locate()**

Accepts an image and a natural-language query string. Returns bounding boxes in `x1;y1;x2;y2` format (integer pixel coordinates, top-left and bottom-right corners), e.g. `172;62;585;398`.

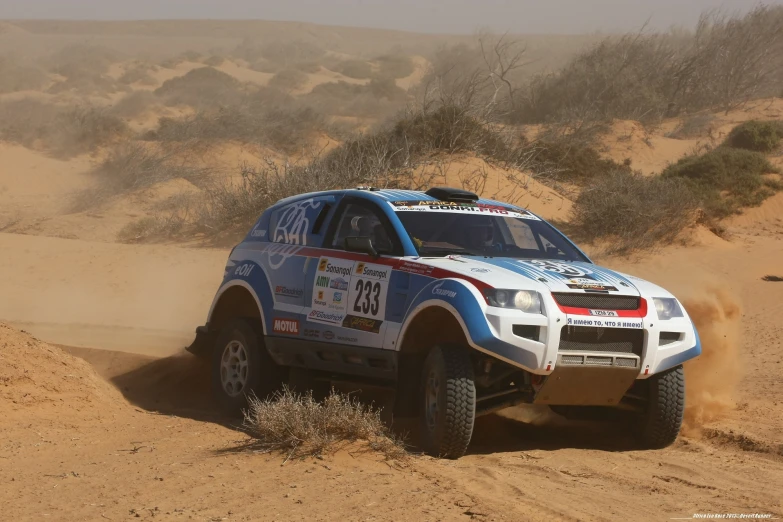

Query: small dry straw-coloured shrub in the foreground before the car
243;389;407;460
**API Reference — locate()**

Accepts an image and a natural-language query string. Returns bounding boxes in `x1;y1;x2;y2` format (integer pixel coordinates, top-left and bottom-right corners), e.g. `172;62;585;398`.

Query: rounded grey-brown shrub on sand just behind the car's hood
567;171;698;253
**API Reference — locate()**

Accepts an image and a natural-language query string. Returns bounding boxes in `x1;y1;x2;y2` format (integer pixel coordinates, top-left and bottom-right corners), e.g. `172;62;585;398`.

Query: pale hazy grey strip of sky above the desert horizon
0;0;783;33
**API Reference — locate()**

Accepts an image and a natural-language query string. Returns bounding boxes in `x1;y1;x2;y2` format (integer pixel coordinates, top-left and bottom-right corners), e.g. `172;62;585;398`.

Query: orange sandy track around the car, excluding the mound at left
0;200;783;520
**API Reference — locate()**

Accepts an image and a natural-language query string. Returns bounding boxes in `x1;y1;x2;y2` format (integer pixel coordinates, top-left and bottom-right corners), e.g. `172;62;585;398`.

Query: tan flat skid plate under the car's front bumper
533;366;639;406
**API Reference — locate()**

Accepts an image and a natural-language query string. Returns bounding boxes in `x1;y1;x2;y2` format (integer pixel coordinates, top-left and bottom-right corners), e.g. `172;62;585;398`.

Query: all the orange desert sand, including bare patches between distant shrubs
0;16;783;521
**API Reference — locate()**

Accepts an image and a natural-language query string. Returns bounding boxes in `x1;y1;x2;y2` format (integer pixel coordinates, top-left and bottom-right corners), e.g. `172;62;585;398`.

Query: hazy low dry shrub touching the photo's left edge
0;100;129;157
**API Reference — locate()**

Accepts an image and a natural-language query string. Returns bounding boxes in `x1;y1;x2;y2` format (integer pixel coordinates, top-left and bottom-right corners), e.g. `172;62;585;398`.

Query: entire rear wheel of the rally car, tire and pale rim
212;319;285;414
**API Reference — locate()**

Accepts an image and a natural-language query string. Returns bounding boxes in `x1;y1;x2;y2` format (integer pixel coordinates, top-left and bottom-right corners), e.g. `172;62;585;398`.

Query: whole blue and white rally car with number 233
190;188;701;458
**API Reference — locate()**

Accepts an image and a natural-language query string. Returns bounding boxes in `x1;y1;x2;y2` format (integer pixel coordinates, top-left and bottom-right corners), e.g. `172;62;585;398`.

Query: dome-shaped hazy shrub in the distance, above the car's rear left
155;67;244;108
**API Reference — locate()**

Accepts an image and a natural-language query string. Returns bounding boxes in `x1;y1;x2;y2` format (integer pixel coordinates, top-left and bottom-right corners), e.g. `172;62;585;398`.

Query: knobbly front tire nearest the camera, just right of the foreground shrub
419;345;476;459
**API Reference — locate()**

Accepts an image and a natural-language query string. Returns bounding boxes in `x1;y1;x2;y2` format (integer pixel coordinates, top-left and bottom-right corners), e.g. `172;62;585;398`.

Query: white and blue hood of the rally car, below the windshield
416;256;641;296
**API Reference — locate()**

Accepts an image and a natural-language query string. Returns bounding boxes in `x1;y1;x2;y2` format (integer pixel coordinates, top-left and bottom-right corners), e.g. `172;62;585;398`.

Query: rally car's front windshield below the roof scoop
396;207;587;261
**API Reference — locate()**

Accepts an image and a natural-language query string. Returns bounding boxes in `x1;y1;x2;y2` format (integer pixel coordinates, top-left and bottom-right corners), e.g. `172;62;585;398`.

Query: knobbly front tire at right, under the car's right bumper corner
634;366;685;449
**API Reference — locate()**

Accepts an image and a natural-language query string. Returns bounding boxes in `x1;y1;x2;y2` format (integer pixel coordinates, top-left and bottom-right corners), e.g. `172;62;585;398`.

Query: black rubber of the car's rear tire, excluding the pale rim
211;319;287;415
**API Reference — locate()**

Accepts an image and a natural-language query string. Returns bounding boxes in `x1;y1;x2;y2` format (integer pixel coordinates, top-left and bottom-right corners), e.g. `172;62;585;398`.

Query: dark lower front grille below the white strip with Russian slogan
560;326;644;357
